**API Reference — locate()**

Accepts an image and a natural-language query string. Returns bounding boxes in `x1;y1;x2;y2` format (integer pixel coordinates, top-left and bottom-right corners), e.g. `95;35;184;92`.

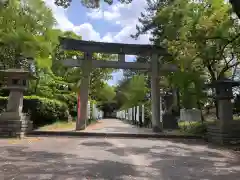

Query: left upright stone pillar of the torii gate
76;53;92;130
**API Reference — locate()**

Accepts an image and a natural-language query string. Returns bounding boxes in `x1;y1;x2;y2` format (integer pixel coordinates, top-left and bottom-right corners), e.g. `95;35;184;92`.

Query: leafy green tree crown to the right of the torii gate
133;0;240;112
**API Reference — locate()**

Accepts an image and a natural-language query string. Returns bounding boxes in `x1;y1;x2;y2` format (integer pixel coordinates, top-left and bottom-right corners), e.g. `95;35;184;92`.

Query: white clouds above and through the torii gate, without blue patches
43;0;150;84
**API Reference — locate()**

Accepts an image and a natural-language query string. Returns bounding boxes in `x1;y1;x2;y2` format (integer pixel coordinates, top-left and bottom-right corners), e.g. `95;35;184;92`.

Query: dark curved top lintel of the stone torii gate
60;37;168;56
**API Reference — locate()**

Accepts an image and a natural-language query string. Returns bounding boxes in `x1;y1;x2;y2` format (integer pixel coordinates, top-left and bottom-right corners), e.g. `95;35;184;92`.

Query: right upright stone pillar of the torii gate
151;54;162;132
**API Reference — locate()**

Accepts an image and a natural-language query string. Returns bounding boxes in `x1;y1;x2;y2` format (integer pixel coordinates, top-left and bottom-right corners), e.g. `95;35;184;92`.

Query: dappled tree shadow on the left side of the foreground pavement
0;146;142;180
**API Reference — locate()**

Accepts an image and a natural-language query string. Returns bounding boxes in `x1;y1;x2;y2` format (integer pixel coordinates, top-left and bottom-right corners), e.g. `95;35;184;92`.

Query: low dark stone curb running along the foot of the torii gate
26;131;203;139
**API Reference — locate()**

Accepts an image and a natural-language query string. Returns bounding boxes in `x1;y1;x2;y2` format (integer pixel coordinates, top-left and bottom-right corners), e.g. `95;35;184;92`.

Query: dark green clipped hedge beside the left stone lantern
0;96;68;128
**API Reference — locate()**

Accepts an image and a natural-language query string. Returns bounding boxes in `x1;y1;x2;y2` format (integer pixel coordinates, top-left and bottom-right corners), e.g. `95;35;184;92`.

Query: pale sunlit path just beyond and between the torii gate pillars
84;119;152;133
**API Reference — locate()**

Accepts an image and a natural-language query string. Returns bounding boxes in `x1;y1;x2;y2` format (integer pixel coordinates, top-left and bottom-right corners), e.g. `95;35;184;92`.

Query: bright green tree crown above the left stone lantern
0;0;57;68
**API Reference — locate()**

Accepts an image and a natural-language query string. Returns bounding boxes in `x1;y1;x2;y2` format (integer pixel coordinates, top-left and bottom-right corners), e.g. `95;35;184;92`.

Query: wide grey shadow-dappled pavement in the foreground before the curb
0;137;240;180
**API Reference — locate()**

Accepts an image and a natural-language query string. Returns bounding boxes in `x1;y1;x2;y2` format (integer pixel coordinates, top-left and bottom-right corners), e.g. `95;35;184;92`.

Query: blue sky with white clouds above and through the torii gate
44;0;150;85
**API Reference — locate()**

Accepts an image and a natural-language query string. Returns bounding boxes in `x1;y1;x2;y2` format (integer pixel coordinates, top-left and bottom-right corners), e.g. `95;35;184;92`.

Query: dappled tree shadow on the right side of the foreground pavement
107;141;240;180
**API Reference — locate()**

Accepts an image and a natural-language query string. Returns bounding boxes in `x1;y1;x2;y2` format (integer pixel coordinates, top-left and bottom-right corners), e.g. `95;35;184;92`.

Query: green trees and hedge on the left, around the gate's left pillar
0;0;116;126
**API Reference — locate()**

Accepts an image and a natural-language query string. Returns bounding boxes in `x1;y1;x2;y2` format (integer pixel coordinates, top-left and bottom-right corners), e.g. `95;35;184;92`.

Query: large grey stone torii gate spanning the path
60;37;176;132
